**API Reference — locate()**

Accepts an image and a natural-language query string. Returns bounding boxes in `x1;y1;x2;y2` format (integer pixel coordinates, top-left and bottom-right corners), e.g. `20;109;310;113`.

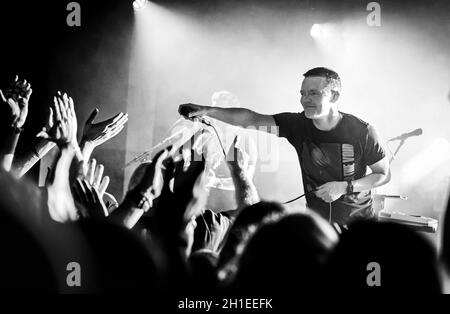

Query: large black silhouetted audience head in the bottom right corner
326;221;440;293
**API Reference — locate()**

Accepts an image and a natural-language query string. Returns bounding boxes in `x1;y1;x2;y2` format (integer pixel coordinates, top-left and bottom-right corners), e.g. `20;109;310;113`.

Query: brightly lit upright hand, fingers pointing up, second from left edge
36;92;78;147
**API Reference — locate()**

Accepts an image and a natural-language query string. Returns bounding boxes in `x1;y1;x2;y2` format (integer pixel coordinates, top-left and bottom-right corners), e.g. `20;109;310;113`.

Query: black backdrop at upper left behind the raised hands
0;1;133;197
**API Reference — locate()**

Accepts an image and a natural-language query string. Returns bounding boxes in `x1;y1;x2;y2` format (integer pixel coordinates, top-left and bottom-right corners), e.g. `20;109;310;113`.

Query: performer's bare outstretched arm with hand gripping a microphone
178;103;276;132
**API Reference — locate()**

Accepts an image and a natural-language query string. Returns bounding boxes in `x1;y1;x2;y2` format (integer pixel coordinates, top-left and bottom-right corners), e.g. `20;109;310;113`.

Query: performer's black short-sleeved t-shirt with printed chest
273;112;385;224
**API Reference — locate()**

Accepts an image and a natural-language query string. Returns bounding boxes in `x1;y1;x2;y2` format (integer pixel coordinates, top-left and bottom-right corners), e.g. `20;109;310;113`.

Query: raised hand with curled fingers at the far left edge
0;75;33;128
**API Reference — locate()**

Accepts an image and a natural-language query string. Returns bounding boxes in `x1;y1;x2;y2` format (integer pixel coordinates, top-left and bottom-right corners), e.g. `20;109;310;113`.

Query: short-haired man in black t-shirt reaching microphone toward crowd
180;67;390;225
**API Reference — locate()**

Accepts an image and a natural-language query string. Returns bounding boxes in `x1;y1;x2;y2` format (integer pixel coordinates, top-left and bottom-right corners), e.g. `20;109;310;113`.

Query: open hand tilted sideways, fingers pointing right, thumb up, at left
82;108;128;146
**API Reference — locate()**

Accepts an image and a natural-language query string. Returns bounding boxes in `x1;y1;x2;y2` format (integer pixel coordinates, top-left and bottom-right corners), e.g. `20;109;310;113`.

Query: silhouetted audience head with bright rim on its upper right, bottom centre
234;212;338;295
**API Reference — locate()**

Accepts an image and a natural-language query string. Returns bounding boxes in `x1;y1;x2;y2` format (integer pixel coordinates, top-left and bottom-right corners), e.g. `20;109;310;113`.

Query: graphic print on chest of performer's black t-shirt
302;140;355;191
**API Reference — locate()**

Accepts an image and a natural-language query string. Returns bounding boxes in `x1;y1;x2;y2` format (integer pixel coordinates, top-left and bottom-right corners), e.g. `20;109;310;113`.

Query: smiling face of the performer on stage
300;77;334;119
